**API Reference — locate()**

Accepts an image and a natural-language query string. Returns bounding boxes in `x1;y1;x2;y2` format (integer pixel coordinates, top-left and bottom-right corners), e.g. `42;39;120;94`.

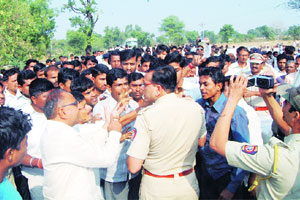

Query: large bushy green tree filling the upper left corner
0;0;55;66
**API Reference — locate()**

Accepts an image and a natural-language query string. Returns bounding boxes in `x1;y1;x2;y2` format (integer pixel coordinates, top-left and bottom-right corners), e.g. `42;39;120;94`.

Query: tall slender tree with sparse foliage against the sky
64;0;99;53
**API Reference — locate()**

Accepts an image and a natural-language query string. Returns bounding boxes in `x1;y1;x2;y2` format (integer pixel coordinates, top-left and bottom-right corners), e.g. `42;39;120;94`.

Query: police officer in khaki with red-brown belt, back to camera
127;66;206;199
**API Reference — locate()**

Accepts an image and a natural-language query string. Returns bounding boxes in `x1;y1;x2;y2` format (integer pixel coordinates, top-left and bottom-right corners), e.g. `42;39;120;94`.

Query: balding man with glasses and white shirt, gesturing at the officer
41;90;122;200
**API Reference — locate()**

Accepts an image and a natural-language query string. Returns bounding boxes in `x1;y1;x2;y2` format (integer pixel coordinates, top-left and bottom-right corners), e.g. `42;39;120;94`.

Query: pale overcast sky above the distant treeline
50;0;300;39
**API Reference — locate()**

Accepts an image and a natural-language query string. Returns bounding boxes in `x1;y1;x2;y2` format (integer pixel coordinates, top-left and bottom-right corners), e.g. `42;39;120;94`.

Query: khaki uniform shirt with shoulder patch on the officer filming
226;134;300;199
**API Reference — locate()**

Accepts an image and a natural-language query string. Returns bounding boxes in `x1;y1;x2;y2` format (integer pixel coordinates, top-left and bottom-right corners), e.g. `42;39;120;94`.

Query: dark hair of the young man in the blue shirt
199;67;225;92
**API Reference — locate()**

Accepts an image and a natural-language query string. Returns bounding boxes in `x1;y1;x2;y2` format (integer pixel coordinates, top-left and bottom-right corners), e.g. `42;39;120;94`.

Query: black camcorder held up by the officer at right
225;75;274;89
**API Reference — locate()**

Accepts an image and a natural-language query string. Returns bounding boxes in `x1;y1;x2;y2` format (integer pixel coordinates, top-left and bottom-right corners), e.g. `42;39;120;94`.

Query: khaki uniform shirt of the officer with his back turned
127;93;206;175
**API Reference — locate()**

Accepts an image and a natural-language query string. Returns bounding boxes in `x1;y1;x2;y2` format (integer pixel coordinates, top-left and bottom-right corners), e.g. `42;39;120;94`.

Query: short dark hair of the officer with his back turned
151;65;177;92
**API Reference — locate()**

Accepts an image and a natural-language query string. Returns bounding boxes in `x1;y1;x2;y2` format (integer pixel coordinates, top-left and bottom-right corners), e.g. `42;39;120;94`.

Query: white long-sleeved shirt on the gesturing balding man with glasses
41;120;121;200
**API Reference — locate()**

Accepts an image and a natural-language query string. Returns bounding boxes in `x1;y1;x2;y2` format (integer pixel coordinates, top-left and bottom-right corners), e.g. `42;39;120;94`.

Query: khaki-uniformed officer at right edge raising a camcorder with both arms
210;77;300;199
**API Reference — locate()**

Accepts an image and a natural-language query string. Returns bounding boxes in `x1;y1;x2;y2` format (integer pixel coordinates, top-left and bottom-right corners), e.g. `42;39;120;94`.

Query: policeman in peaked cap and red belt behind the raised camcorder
243;53;274;143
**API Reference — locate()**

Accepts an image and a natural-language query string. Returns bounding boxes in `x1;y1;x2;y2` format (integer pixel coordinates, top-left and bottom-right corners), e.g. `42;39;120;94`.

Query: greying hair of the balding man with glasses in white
43;89;65;119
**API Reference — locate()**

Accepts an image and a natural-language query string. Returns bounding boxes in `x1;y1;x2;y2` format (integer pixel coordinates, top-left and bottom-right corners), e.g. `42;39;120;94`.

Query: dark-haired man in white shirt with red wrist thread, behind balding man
22;79;54;200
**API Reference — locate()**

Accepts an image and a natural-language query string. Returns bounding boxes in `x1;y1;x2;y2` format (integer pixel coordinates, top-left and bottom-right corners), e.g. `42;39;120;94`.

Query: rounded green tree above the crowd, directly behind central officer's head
159;16;186;45
